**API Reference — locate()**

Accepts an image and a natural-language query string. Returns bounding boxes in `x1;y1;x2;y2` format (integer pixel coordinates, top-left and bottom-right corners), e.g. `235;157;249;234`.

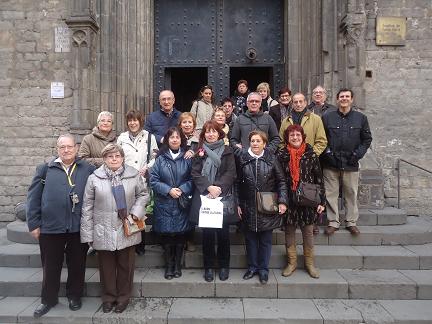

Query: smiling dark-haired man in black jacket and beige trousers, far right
322;89;372;235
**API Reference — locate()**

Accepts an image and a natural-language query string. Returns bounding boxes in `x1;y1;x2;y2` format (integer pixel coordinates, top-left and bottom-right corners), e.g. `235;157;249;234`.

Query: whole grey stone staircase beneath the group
0;208;432;324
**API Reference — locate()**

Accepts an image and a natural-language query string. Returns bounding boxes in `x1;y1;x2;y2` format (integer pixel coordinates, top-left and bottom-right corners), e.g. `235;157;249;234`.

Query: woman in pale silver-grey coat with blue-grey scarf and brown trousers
81;144;148;313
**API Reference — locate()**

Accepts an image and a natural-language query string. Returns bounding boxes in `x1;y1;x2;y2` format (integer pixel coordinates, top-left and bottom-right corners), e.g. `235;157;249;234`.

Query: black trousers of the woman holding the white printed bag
202;224;230;269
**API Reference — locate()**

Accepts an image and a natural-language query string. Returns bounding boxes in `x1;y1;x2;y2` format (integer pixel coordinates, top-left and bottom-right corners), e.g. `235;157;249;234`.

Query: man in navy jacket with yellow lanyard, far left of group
27;134;95;318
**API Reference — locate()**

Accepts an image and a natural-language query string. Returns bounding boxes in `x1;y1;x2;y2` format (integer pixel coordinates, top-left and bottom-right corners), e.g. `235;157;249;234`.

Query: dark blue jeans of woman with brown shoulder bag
245;229;273;274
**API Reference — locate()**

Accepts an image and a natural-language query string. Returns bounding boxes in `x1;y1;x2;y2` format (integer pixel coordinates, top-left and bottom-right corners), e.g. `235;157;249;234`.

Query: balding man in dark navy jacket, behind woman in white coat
144;90;181;147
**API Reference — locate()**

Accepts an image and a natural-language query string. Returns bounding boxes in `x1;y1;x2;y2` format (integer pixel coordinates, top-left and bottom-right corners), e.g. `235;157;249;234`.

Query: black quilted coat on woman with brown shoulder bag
236;150;288;232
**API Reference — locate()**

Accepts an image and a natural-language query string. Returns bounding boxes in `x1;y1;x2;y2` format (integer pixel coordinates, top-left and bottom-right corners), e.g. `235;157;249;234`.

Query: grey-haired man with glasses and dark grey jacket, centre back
230;92;280;153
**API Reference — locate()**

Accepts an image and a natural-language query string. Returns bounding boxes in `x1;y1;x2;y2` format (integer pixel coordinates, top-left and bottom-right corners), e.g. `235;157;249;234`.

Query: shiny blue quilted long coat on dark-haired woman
150;152;193;233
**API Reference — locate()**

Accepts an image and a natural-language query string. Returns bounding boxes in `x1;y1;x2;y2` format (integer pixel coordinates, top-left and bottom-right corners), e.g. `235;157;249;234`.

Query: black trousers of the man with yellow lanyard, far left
39;232;88;305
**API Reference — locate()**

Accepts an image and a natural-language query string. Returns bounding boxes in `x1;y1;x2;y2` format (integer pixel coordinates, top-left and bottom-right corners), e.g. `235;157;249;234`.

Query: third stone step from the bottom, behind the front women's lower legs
0;243;432;270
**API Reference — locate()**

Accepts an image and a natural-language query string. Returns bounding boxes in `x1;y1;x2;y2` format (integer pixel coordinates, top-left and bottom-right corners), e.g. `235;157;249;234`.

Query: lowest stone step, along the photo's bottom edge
0;297;432;324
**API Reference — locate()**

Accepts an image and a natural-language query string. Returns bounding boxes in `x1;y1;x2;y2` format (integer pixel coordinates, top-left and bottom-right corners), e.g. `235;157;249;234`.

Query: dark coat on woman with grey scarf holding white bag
189;146;237;224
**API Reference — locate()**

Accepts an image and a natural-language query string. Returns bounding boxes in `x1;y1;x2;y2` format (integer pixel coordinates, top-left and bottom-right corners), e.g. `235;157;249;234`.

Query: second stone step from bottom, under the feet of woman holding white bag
0;268;432;300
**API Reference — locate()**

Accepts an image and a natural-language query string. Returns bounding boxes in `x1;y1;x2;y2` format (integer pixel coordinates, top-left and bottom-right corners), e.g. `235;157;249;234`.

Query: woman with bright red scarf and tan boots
278;125;325;278
